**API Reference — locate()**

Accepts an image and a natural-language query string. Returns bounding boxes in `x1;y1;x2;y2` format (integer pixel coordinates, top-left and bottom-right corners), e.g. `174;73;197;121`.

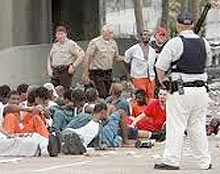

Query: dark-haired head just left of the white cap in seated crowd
35;86;50;107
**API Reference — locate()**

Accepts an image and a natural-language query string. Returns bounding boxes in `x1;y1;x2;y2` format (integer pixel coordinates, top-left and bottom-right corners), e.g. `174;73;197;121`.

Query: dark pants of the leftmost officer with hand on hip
51;65;73;88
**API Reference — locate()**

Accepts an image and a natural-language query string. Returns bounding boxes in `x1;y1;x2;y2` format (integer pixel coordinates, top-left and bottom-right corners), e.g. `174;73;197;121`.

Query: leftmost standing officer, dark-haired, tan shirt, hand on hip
48;26;84;88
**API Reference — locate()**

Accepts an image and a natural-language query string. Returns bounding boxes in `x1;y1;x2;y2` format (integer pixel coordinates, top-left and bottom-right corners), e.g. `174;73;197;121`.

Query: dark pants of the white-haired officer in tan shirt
89;70;112;98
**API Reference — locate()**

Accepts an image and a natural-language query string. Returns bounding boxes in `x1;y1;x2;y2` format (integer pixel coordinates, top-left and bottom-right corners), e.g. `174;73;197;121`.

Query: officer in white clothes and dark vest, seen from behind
154;12;212;170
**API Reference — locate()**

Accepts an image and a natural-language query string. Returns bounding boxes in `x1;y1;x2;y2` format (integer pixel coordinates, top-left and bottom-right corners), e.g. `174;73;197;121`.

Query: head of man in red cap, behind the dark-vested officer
154;27;168;46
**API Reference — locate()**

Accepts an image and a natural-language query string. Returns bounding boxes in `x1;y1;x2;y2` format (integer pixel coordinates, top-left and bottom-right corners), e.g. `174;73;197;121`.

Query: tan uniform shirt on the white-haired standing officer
86;36;119;70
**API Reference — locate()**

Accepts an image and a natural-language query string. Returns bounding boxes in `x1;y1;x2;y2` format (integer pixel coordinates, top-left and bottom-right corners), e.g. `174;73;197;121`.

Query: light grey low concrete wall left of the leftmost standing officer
0;44;50;88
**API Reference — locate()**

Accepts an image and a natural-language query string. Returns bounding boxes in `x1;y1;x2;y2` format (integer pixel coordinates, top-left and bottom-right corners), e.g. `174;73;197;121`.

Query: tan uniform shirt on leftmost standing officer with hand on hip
50;39;84;67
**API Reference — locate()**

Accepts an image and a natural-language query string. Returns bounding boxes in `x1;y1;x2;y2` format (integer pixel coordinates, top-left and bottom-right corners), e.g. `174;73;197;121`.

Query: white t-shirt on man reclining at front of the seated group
64;120;99;147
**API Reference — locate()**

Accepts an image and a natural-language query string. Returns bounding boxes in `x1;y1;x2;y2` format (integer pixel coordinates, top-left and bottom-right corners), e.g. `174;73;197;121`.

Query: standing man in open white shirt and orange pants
124;30;157;100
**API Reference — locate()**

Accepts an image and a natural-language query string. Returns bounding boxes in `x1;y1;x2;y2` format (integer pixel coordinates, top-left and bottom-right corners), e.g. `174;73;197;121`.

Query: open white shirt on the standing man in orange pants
124;44;157;78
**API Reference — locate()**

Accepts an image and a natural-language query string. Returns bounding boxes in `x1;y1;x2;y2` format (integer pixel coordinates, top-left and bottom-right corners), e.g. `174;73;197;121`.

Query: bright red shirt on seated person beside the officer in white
136;99;166;132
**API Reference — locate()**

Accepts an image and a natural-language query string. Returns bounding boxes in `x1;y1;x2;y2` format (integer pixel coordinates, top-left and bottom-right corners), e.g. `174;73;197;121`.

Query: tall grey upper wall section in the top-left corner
0;0;51;49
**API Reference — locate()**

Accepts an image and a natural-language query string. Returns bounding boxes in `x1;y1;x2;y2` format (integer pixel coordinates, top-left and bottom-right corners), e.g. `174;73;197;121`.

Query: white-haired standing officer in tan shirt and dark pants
82;24;119;98
